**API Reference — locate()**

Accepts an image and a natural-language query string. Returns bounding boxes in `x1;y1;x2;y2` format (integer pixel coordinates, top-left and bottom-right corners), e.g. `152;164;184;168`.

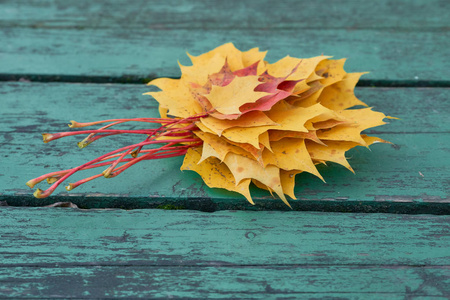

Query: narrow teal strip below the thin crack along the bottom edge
0;266;450;299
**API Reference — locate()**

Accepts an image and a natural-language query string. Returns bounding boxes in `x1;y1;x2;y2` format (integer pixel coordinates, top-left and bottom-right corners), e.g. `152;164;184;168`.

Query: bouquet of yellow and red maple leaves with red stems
27;43;392;205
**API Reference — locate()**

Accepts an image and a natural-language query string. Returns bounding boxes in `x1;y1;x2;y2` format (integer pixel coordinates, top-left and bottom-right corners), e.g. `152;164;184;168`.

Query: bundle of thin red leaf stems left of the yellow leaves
27;113;207;198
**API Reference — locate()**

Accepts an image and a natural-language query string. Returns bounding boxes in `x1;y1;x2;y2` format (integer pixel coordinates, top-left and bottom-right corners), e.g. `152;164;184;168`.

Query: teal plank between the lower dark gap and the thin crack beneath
0;207;450;268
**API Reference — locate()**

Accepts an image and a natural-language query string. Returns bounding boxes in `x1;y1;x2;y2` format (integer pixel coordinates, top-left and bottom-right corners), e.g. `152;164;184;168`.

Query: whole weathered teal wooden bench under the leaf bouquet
0;0;450;299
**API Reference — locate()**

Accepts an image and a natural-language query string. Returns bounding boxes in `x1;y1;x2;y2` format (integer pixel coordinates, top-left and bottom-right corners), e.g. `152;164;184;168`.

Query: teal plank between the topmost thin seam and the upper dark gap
0;27;450;81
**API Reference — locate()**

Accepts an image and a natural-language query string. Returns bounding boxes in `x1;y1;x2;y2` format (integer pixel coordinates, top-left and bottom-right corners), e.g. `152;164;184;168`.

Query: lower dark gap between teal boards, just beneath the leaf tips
0;198;450;215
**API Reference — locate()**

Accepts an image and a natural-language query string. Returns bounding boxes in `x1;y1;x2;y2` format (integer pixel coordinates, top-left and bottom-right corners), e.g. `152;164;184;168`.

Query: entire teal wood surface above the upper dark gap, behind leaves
0;0;450;81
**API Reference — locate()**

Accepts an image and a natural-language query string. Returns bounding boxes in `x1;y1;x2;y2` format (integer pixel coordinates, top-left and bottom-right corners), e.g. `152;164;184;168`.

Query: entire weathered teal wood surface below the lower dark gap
0;207;450;299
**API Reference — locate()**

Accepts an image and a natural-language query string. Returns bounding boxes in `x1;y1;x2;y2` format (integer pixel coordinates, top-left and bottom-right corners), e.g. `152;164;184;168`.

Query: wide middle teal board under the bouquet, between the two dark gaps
0;83;450;209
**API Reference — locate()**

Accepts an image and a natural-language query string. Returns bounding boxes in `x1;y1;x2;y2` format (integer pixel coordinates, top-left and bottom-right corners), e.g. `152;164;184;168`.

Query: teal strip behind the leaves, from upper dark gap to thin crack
0;82;450;135
